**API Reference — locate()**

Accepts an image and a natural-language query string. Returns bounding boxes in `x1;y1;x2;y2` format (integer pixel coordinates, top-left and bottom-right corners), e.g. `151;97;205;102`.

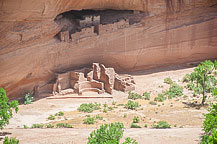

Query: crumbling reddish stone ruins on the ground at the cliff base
38;63;135;95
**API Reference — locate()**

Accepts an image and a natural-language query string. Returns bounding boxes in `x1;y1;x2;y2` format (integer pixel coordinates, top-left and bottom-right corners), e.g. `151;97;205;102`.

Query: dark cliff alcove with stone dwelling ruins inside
54;10;146;41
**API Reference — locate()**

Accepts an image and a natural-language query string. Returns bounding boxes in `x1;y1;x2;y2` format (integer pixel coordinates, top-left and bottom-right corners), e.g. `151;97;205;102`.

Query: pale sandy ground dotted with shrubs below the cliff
0;67;213;144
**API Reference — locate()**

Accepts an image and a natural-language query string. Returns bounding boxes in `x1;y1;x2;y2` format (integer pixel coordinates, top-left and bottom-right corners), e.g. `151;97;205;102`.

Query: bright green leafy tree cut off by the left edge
0;88;19;129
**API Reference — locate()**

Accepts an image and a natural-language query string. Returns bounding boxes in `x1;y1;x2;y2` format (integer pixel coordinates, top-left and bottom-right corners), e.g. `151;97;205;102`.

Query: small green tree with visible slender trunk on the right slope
190;60;217;105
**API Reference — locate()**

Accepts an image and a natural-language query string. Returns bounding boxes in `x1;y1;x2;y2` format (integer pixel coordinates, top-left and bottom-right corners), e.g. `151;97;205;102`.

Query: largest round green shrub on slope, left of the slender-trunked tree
165;83;183;99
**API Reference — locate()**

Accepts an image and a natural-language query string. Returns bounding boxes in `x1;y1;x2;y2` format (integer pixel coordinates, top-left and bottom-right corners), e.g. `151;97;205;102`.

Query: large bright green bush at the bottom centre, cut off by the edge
87;122;124;144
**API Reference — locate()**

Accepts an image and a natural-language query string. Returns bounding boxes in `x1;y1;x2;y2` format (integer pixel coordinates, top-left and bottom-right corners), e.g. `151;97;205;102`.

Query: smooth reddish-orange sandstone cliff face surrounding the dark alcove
0;0;217;98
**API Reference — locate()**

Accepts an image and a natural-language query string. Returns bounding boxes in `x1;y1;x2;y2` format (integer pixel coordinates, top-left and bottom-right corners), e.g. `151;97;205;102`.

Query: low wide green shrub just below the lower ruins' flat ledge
78;103;100;113
